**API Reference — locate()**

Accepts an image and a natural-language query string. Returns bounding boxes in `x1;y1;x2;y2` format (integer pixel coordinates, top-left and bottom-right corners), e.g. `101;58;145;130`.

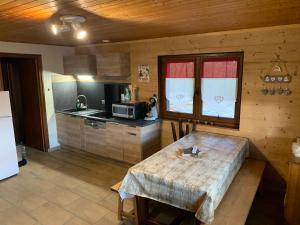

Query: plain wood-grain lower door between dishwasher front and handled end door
106;123;124;161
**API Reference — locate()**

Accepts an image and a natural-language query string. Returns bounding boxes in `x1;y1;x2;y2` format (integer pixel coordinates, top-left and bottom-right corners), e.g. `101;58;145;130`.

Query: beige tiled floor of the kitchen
0;150;282;225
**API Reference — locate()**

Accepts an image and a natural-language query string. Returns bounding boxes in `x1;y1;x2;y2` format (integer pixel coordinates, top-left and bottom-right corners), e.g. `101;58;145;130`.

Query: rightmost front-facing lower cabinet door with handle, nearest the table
123;127;142;164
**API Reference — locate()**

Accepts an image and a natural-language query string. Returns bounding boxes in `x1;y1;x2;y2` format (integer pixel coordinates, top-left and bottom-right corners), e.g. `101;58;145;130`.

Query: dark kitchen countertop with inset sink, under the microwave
56;109;161;127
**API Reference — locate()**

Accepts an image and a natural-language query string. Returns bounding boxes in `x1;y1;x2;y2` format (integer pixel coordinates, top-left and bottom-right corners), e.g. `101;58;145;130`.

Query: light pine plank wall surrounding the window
76;25;300;183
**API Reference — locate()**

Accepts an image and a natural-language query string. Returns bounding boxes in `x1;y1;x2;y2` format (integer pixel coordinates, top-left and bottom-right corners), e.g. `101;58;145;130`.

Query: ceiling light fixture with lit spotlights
51;16;87;40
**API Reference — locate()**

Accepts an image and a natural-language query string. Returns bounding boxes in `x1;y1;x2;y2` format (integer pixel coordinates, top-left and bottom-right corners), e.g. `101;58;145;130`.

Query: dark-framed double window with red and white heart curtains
159;52;243;128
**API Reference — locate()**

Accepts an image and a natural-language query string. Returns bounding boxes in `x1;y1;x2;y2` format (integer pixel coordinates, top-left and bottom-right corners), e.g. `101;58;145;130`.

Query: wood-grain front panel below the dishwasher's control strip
84;126;108;157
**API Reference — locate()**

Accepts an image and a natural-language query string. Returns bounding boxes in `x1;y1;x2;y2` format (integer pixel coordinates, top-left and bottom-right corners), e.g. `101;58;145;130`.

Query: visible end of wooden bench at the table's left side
110;181;138;225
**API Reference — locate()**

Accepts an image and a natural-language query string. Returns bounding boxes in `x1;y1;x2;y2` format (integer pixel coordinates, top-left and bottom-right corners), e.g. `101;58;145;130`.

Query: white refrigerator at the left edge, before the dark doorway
0;91;19;180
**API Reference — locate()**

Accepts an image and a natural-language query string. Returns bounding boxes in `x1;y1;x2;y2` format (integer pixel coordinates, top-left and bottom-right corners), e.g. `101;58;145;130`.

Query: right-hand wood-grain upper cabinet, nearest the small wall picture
97;53;130;78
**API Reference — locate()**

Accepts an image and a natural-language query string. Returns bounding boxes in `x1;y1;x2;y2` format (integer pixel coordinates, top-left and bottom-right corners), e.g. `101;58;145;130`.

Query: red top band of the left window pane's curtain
166;62;194;78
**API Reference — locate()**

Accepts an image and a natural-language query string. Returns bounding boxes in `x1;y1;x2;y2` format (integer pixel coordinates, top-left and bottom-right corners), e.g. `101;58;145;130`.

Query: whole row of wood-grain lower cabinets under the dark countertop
57;113;160;164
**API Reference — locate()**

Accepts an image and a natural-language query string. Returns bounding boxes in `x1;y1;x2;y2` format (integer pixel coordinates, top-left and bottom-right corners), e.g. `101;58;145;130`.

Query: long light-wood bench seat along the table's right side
202;159;266;225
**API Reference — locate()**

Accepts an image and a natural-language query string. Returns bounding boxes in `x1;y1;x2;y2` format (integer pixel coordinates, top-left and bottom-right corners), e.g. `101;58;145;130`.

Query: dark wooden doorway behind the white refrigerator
0;53;49;151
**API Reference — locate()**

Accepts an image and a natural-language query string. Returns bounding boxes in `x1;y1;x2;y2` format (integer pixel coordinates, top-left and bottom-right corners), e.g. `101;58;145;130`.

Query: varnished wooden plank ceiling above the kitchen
0;0;300;46
